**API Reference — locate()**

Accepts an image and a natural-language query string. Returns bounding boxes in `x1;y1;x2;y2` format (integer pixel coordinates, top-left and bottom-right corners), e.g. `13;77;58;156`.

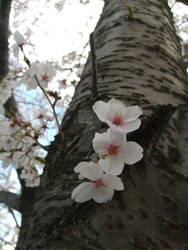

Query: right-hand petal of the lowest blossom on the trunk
102;174;124;190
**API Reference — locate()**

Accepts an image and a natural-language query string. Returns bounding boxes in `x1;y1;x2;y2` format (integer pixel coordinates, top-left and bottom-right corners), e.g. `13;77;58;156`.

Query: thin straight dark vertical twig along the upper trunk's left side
89;32;98;99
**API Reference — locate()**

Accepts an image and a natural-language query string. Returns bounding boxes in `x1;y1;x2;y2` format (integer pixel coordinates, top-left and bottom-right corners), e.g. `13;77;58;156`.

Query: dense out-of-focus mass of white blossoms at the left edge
0;114;50;187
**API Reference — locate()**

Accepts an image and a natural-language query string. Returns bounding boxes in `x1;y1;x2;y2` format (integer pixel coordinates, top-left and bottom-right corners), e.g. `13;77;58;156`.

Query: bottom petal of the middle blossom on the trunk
99;158;124;175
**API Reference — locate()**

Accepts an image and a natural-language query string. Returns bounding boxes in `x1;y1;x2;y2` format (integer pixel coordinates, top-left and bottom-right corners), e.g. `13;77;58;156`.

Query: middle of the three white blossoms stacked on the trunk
93;129;143;175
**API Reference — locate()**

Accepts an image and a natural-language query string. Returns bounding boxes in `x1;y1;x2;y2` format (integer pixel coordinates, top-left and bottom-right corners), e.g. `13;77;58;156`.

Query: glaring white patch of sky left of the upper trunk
11;0;103;63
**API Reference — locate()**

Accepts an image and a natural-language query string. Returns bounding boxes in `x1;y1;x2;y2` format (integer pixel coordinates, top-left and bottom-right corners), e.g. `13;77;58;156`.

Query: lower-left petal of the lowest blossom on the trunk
71;182;95;203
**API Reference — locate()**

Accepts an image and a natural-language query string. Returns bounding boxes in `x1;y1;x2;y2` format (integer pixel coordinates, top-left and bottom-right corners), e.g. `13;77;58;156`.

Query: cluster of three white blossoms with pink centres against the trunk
71;98;143;203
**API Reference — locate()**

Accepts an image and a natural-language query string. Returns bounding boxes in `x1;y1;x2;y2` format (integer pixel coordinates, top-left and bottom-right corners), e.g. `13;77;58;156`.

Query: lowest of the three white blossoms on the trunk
71;162;124;203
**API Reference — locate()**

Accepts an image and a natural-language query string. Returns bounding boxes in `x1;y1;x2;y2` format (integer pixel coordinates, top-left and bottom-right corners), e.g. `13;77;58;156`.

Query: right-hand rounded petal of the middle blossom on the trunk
120;142;143;165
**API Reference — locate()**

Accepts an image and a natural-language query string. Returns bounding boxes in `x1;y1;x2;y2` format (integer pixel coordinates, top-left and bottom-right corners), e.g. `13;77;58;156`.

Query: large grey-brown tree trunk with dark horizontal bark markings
17;0;188;250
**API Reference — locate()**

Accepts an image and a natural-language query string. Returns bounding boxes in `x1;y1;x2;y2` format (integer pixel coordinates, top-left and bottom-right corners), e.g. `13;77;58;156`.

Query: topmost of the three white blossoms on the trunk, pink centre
93;98;142;133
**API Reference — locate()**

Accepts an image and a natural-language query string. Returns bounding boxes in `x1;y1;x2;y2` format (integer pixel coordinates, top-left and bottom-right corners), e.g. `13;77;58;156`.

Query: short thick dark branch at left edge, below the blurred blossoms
0;191;21;212
